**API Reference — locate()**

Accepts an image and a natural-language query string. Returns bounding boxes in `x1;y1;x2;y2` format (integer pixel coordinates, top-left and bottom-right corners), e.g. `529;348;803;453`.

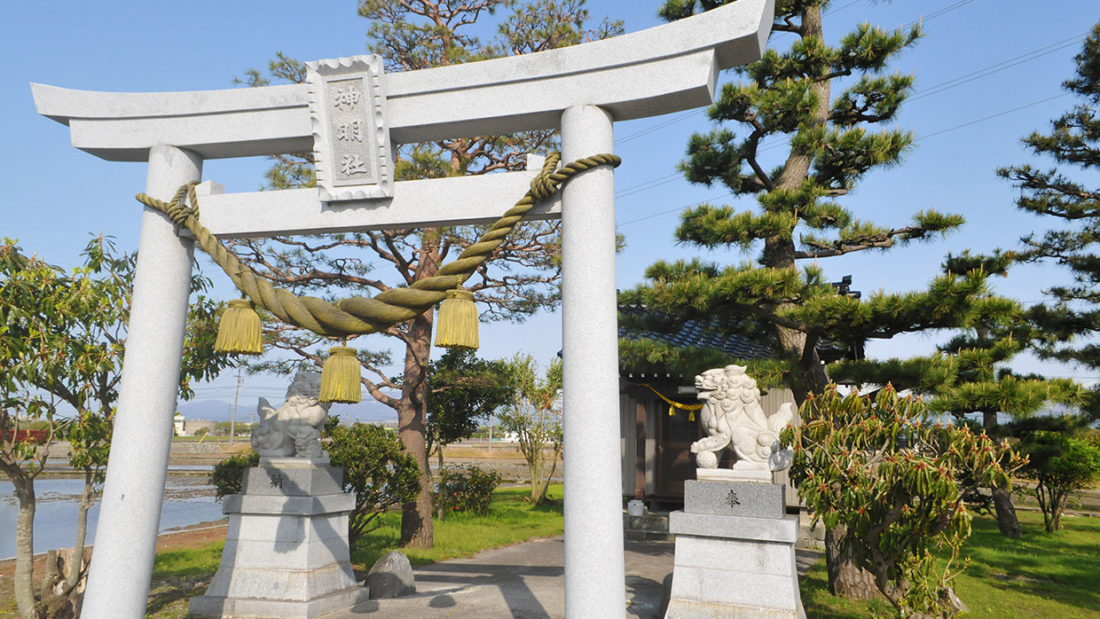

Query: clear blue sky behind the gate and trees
0;0;1100;406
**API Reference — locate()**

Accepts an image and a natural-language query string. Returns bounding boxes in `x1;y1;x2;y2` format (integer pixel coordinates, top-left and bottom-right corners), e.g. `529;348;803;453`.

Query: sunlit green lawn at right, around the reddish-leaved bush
801;511;1100;619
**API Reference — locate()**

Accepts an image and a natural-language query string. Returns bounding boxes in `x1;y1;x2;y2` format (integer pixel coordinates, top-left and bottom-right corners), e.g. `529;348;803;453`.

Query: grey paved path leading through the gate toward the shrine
325;537;821;619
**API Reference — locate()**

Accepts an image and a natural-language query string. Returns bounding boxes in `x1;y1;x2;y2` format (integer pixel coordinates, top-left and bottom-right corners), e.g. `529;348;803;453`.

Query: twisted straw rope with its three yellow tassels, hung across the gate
136;153;622;402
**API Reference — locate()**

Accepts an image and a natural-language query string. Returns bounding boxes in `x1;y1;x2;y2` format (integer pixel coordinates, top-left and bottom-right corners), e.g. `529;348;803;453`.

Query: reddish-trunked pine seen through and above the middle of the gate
238;0;622;546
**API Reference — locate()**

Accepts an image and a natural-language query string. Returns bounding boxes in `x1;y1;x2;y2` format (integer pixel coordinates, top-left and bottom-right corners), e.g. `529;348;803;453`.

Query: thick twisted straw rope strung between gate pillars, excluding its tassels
138;153;622;338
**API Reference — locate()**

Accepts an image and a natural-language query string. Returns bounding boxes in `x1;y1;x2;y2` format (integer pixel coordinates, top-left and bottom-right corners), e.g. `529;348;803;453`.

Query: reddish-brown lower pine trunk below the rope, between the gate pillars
397;310;435;548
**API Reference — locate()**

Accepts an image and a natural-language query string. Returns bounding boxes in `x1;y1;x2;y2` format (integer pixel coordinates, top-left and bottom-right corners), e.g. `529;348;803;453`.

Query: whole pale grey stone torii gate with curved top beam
31;0;772;619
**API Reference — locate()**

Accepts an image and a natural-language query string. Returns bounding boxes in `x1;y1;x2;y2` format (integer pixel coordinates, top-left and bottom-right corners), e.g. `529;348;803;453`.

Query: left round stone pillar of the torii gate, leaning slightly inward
84;144;202;617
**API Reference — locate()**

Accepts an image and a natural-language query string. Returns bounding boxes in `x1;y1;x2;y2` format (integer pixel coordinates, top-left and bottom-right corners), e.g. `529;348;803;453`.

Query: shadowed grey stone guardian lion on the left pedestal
252;372;331;457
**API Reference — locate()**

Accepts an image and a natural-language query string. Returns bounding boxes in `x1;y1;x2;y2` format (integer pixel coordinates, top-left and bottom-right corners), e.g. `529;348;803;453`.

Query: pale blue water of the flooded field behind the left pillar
0;474;222;559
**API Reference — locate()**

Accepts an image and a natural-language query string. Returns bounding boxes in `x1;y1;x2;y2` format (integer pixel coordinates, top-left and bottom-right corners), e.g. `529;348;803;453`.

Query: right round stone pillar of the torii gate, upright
561;106;626;617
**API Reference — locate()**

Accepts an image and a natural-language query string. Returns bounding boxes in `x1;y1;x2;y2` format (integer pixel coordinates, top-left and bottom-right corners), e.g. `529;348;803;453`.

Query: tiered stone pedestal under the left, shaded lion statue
184;457;369;618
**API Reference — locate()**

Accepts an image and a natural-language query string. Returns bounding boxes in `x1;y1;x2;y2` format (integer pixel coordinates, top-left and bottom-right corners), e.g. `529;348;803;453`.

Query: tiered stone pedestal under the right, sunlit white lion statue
664;480;805;619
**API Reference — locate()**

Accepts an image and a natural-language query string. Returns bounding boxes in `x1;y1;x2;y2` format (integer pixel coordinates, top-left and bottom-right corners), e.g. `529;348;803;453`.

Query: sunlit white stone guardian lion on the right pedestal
691;365;795;472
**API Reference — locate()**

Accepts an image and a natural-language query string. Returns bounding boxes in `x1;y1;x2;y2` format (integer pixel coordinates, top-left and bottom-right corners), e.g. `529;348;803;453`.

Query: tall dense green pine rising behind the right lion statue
620;0;986;597
